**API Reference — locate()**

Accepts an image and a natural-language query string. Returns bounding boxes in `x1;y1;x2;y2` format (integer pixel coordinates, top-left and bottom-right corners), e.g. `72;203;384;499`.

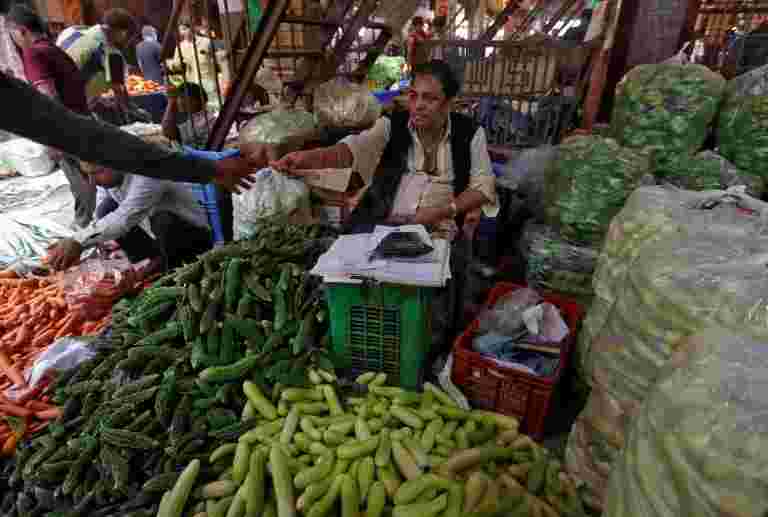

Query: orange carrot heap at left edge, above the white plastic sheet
0;271;110;392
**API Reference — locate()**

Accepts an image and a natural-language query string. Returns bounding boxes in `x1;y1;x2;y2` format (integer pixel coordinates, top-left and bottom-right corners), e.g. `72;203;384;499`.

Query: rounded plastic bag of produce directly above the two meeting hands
240;109;319;163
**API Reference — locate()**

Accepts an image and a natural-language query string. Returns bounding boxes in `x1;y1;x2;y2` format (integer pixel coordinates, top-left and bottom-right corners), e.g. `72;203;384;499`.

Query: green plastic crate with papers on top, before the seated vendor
326;284;433;389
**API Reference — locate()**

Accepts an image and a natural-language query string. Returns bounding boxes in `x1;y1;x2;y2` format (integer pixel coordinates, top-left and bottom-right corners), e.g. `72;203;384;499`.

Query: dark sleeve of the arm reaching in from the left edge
0;73;216;183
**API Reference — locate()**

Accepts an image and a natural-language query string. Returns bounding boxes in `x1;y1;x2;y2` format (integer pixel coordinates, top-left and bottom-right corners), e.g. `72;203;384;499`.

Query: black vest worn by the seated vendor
344;112;477;233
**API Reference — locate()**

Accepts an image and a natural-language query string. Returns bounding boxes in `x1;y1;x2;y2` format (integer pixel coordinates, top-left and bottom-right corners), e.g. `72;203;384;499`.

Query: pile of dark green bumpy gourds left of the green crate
0;225;340;517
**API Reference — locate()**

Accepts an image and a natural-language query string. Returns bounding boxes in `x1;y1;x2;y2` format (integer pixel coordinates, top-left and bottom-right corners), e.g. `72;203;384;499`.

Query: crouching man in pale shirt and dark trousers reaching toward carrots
47;163;213;271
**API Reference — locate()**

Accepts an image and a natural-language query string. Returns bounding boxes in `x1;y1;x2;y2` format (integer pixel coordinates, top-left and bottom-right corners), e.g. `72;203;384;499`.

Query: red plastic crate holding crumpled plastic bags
452;283;584;440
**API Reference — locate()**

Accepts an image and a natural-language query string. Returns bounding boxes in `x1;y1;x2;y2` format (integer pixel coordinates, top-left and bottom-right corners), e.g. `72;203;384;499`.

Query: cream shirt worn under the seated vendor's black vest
342;117;499;233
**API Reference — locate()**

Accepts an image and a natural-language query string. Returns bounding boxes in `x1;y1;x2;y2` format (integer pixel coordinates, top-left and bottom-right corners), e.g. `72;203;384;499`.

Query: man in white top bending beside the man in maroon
56;9;137;109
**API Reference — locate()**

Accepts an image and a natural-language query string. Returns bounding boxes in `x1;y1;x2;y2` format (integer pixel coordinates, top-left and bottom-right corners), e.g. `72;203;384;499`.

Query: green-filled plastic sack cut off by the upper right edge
716;63;768;178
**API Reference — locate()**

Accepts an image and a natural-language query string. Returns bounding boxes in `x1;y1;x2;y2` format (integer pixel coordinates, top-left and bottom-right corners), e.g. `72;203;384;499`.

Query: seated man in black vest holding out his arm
272;60;498;358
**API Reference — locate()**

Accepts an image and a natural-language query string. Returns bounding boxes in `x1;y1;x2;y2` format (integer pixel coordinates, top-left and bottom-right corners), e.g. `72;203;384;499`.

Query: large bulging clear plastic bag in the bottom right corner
604;327;768;517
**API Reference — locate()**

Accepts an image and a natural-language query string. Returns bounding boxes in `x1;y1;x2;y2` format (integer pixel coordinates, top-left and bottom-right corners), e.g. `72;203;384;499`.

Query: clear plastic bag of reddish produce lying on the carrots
62;258;142;320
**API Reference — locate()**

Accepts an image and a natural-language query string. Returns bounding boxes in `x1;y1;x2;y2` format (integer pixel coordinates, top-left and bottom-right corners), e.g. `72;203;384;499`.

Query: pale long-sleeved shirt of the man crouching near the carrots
74;174;208;248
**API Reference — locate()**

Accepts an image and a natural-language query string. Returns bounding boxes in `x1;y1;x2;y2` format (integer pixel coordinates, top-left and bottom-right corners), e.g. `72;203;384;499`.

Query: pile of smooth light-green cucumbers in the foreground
164;373;585;517
